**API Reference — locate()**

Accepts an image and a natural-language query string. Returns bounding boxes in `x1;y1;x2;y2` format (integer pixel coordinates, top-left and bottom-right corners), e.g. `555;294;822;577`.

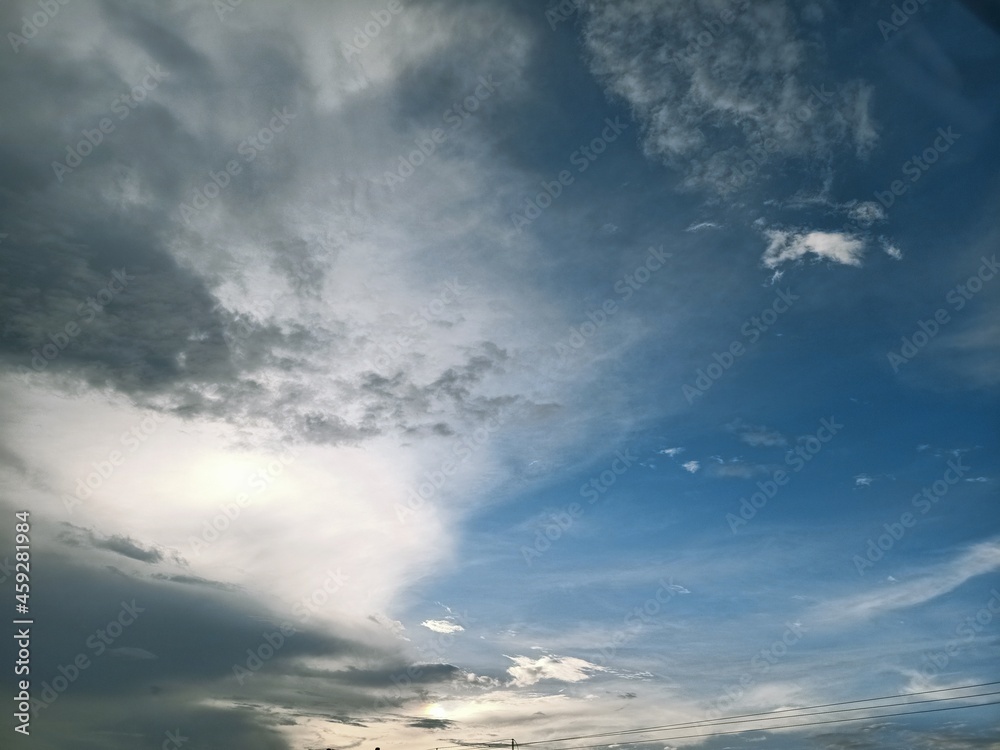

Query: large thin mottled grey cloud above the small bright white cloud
584;0;877;193
